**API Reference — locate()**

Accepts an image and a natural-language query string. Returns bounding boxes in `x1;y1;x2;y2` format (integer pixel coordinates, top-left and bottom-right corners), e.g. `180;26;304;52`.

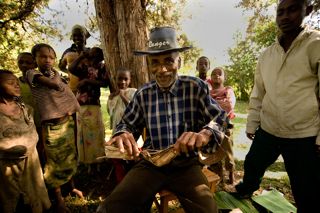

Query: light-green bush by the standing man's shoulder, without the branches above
226;18;278;101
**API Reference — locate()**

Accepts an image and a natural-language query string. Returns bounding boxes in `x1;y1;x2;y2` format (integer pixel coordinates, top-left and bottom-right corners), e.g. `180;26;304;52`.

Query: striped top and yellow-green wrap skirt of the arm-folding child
26;69;80;188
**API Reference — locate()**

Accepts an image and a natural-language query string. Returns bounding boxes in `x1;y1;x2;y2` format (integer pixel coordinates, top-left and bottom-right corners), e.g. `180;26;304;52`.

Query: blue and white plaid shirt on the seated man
114;76;221;150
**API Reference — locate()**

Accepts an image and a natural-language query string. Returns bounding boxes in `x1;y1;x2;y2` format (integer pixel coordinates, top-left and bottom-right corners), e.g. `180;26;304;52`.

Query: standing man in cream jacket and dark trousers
236;0;320;212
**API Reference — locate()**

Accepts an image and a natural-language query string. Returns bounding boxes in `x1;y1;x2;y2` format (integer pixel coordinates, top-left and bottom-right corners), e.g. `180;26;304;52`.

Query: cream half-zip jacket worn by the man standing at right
246;29;320;145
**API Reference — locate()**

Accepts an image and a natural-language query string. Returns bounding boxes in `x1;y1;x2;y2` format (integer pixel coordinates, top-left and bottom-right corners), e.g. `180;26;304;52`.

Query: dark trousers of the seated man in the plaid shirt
99;157;217;213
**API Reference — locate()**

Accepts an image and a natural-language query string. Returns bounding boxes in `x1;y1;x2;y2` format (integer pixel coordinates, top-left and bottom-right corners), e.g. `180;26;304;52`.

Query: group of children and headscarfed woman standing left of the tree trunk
0;26;112;213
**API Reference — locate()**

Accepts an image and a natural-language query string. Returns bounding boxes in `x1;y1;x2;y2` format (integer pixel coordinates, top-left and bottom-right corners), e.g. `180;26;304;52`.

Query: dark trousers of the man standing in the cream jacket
236;128;320;213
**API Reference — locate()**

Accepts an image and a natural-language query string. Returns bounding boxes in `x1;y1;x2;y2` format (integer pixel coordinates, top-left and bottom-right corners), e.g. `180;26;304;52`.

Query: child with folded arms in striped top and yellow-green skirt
26;43;83;212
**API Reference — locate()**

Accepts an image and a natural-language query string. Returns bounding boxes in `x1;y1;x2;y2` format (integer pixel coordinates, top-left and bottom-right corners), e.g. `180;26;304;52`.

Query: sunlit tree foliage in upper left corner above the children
0;0;59;71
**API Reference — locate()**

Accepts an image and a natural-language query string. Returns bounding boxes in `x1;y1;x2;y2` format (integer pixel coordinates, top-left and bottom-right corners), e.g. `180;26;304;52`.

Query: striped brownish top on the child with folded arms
26;69;80;121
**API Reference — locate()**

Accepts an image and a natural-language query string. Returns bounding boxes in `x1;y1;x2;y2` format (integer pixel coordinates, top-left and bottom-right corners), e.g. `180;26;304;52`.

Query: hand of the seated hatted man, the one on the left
106;132;140;159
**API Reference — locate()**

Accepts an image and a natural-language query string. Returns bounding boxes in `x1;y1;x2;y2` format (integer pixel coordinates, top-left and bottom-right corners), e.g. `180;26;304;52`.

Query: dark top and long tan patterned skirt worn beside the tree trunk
74;64;110;164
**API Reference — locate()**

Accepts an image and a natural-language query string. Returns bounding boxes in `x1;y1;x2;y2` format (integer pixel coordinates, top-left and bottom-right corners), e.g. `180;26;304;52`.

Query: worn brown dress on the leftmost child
0;103;51;213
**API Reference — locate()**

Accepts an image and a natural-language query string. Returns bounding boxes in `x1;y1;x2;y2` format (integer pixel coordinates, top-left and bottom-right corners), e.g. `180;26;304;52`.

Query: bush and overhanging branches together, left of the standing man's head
226;0;278;101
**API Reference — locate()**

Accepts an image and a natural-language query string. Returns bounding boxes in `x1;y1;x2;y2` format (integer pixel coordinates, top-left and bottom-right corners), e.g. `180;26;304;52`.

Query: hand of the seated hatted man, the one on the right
173;129;212;154
